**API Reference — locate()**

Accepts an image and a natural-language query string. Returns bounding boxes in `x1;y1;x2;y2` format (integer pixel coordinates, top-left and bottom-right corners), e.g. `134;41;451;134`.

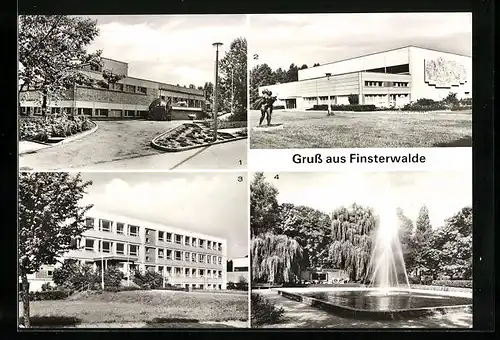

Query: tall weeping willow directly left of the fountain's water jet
329;203;377;281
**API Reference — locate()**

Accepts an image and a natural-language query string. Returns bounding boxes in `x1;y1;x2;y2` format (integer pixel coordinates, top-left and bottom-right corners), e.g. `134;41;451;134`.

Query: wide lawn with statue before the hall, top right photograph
250;111;472;149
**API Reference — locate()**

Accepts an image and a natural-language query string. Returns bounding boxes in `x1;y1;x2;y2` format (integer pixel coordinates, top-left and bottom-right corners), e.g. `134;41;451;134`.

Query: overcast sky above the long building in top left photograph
89;15;247;86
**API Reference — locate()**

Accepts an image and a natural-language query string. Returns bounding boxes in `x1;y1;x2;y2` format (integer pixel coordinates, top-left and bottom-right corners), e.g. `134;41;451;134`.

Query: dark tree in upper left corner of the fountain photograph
250;172;279;236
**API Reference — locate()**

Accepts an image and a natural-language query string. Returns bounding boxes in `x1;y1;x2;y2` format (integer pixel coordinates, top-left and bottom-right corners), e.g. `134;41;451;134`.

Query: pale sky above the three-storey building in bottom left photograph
82;172;249;259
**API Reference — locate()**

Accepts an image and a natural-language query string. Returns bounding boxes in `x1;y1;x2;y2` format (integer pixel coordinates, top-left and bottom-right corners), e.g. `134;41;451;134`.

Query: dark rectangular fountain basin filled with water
278;288;472;320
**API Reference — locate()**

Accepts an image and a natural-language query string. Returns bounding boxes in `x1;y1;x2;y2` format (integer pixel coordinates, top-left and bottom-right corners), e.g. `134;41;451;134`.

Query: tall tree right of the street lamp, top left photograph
218;37;247;115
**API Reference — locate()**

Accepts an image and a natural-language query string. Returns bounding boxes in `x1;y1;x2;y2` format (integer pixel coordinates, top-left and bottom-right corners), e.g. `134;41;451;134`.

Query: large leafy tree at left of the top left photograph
18;15;102;115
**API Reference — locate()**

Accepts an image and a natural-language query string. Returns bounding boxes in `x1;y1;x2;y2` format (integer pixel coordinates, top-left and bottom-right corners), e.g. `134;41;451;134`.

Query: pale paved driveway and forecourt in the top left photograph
19;120;247;170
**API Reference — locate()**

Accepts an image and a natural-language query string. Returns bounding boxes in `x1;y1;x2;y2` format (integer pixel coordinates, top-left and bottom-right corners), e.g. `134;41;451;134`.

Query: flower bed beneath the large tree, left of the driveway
19;115;94;142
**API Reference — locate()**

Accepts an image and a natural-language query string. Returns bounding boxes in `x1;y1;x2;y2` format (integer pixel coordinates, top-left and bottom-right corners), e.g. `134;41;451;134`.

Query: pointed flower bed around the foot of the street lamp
152;123;247;150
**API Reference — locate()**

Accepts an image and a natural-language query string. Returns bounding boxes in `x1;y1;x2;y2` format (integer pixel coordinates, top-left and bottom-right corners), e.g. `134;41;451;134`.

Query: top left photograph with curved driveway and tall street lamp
18;15;248;171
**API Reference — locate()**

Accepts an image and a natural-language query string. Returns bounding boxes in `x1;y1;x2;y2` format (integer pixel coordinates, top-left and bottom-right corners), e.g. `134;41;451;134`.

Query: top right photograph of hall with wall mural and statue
248;13;472;149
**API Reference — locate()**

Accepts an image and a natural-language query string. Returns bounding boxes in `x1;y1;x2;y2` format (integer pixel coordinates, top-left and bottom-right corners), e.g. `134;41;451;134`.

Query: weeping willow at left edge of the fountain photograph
251;233;302;284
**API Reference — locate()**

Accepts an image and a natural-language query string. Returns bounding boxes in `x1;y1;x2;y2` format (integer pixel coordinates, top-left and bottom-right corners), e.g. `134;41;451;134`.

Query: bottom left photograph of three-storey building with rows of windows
18;172;250;328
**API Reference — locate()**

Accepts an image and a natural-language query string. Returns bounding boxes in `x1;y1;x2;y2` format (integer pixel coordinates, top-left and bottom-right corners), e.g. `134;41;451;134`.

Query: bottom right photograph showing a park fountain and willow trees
250;169;473;328
